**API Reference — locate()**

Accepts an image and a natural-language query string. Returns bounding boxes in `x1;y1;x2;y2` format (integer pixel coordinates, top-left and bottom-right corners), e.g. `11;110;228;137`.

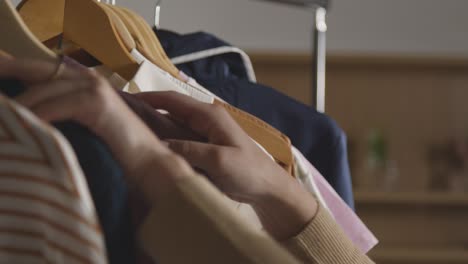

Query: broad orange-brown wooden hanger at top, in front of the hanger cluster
18;0;139;80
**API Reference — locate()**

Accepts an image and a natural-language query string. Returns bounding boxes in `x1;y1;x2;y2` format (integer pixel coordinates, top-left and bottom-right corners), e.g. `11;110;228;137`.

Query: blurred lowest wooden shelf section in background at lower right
356;193;468;250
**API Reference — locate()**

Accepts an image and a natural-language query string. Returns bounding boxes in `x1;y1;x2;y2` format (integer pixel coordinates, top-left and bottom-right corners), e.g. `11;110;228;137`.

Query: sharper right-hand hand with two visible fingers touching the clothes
137;92;317;240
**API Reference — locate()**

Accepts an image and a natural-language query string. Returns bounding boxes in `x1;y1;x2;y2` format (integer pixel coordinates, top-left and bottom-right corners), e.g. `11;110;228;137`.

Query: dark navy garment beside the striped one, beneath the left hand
0;80;135;264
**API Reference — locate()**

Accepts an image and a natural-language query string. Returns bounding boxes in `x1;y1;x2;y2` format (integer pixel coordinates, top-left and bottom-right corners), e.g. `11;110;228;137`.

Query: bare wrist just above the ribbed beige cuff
252;175;318;241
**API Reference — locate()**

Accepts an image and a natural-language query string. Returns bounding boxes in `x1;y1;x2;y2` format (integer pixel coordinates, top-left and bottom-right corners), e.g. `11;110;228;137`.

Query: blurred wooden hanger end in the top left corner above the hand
0;0;57;62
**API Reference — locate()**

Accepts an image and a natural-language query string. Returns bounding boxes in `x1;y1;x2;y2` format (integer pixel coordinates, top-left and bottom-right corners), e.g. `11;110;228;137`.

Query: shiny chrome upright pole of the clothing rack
254;0;330;113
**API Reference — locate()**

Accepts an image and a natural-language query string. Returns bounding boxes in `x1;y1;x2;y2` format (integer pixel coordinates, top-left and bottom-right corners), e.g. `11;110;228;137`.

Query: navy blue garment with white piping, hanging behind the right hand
155;30;354;208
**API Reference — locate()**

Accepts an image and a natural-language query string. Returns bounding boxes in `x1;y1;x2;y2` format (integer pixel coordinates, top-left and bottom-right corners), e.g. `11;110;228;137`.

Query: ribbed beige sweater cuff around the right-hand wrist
283;203;374;264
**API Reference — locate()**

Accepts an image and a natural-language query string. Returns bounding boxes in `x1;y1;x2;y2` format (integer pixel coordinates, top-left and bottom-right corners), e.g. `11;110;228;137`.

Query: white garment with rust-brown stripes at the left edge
0;92;107;264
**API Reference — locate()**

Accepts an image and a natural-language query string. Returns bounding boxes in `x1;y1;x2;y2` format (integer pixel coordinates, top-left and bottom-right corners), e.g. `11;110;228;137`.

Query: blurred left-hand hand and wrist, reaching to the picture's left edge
0;59;195;202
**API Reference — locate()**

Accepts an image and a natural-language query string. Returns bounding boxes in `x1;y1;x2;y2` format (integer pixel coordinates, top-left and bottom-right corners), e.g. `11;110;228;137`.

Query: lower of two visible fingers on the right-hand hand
167;140;227;175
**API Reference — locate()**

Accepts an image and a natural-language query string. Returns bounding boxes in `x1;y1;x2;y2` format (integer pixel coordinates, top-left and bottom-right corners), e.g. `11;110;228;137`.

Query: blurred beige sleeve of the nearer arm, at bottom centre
140;177;299;264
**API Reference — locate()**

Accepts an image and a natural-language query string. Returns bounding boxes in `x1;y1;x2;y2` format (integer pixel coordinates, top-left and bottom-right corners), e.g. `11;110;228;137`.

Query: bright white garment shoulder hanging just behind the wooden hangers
128;50;214;104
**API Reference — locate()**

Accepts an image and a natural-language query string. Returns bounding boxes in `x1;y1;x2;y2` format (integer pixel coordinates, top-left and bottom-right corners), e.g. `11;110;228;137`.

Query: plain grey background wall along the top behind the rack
13;0;468;55
